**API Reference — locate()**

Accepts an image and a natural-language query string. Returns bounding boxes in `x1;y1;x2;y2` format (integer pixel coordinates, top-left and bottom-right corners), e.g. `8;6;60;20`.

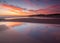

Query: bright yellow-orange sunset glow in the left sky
0;4;32;16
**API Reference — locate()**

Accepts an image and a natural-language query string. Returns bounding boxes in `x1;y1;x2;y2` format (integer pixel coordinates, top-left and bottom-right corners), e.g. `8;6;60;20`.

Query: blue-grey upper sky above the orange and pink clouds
0;0;60;10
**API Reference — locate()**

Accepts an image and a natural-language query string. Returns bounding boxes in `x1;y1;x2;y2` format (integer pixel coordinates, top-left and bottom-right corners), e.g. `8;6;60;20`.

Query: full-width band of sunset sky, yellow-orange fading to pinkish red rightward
0;4;60;16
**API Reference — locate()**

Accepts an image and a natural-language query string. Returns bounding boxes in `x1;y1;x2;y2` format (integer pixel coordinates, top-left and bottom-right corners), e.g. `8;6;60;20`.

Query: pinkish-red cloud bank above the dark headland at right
36;5;60;14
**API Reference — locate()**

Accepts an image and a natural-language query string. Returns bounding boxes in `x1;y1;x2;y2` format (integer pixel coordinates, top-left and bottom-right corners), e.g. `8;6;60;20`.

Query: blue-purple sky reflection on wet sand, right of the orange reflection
14;23;60;43
